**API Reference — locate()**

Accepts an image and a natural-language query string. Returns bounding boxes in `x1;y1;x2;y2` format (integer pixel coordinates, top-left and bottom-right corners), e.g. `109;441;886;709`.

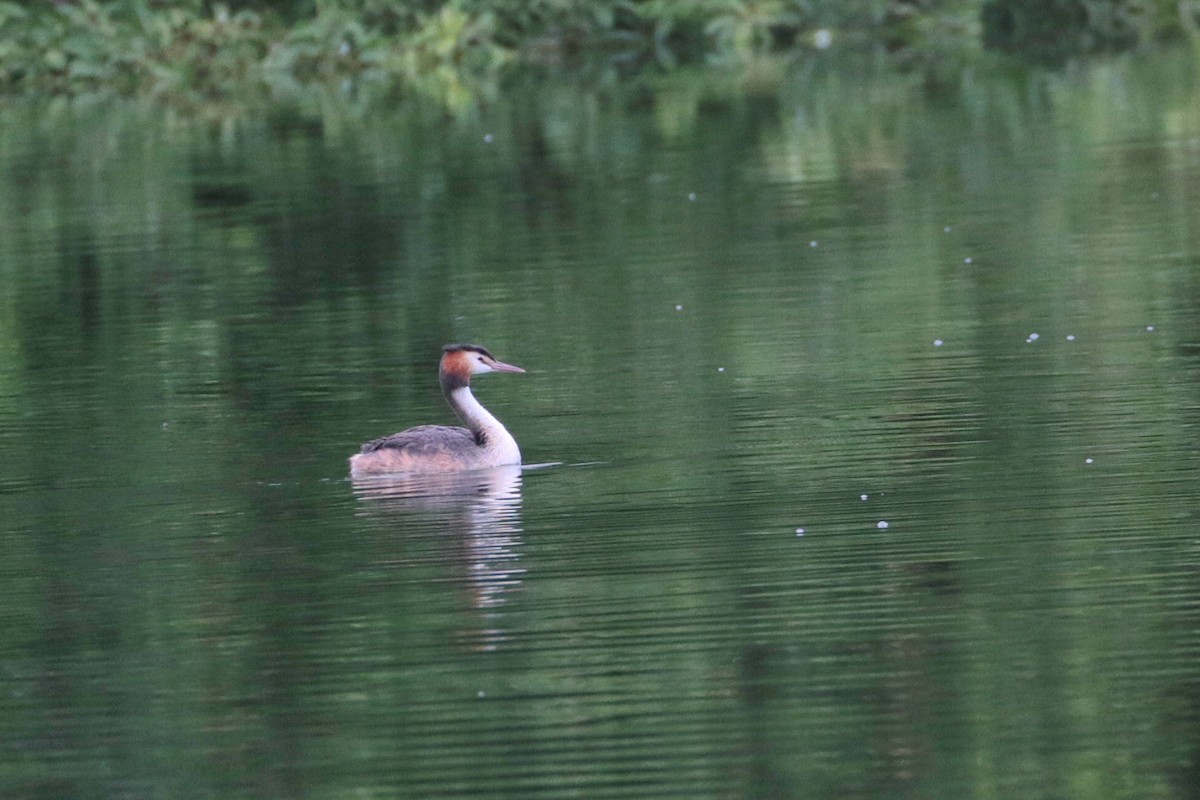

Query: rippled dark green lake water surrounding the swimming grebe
0;53;1200;799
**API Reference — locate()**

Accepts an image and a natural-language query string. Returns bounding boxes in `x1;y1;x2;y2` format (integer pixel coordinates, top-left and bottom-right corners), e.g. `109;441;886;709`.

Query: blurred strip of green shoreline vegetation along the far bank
0;0;1200;110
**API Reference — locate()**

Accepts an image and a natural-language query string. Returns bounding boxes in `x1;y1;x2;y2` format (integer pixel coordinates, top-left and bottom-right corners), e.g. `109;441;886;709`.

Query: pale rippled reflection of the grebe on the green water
353;465;524;650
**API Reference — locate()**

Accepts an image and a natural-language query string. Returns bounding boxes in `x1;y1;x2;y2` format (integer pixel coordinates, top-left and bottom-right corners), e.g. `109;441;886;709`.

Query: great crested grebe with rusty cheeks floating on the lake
350;344;524;477
